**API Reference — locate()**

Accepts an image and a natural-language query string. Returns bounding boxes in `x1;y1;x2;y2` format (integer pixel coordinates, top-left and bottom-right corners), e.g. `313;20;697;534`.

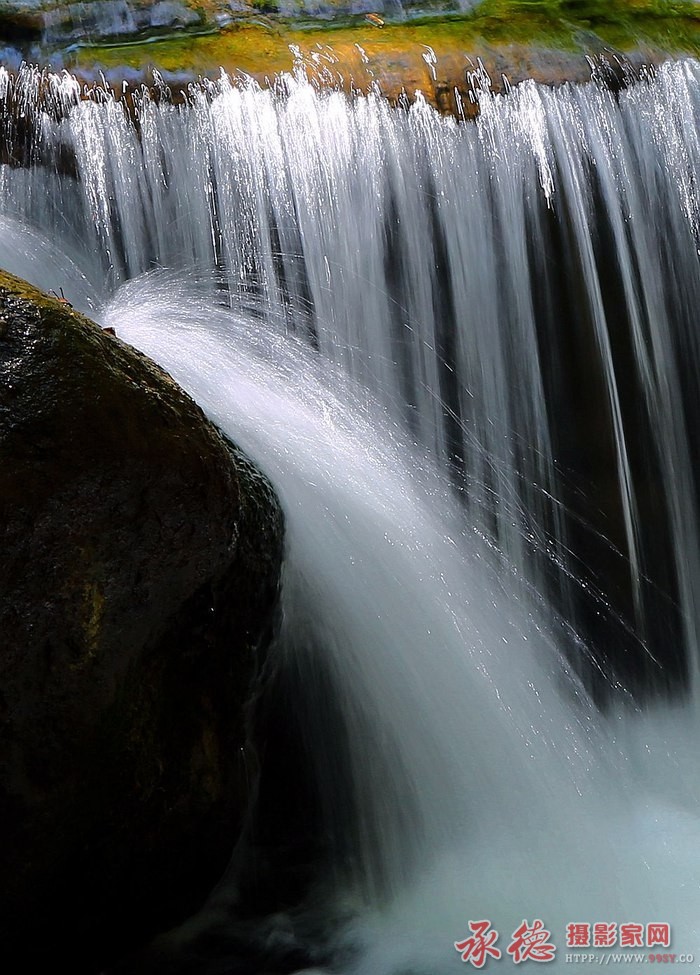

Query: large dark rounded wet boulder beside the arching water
0;273;282;972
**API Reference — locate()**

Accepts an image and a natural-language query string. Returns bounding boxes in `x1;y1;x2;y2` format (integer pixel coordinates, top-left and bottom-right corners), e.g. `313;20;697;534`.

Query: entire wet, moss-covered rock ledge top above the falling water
0;0;700;104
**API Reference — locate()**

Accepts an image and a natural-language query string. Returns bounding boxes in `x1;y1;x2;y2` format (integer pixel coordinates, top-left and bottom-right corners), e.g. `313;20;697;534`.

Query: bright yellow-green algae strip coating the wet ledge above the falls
71;0;700;84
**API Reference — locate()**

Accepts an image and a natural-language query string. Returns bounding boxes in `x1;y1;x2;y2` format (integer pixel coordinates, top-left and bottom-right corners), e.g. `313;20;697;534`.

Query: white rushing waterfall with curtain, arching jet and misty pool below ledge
0;61;700;975
